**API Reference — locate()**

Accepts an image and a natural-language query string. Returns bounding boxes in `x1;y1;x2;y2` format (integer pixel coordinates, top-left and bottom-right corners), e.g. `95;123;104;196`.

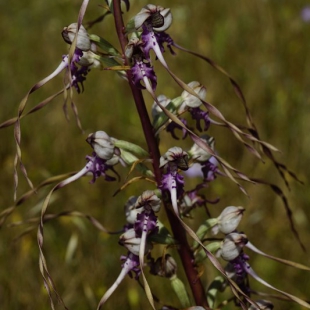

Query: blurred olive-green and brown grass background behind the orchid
0;0;310;310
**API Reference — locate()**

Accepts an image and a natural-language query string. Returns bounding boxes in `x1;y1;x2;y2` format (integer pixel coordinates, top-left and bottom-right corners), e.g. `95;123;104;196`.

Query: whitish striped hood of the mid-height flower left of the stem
86;131;115;160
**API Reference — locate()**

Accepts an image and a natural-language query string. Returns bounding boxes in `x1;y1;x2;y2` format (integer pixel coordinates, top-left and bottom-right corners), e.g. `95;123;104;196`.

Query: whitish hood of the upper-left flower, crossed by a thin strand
61;23;91;51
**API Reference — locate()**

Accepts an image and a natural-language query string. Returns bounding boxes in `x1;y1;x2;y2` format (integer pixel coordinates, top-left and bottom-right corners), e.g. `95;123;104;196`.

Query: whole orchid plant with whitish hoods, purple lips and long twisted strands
0;0;310;310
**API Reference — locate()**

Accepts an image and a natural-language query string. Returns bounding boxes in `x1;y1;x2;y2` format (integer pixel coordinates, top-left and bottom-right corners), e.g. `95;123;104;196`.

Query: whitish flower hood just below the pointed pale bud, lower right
217;233;248;261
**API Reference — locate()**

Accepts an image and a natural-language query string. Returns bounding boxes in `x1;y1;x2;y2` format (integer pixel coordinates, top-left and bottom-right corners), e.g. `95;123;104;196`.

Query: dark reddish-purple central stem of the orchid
113;0;209;309
